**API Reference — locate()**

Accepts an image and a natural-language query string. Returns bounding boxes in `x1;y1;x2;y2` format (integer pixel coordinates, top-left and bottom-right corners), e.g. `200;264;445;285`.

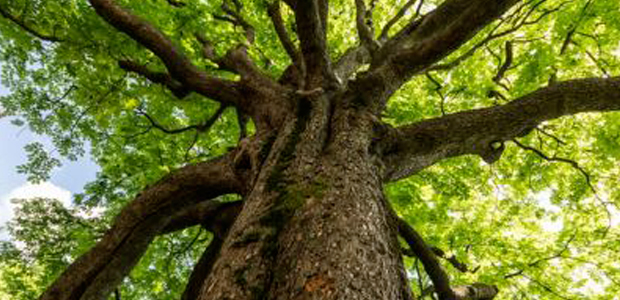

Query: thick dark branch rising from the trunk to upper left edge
90;0;242;105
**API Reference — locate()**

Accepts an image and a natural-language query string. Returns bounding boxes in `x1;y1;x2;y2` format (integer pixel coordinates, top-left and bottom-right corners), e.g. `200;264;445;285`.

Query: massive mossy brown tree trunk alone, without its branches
199;97;410;299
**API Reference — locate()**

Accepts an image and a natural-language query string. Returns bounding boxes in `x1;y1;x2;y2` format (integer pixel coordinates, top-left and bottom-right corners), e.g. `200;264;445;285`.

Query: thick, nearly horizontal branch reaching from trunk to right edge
377;77;620;181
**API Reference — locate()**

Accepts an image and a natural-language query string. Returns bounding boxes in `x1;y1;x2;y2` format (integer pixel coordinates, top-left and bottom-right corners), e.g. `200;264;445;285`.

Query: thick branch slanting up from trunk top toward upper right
360;0;519;111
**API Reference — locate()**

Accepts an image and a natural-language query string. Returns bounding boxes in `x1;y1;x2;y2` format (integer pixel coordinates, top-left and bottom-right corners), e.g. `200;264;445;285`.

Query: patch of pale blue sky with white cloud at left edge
0;81;98;240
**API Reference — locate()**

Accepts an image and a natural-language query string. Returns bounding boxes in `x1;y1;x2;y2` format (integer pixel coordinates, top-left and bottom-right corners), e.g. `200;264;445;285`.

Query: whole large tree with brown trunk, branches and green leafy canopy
0;0;620;300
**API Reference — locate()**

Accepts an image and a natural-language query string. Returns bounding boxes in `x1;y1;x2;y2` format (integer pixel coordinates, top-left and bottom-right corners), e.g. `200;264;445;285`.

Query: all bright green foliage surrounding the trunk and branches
0;0;620;299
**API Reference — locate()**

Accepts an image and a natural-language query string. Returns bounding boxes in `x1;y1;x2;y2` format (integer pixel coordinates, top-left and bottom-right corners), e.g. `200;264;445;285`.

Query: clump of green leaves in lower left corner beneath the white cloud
0;198;104;300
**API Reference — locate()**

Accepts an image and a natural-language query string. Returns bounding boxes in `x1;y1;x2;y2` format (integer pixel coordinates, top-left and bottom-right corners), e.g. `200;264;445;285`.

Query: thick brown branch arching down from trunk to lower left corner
40;153;244;300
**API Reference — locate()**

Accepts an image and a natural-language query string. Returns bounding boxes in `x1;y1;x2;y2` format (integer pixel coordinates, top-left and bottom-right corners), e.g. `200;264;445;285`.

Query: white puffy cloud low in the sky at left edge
0;182;71;240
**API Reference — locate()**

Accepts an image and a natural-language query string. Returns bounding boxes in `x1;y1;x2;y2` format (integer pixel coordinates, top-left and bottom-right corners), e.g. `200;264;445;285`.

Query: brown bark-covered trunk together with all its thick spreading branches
26;0;620;300
